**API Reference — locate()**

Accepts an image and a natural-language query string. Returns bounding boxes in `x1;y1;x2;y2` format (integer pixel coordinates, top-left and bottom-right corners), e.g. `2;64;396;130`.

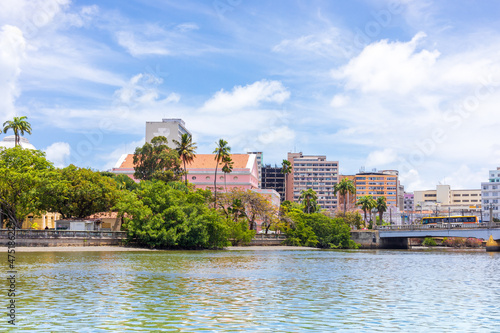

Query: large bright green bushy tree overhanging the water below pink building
118;181;229;249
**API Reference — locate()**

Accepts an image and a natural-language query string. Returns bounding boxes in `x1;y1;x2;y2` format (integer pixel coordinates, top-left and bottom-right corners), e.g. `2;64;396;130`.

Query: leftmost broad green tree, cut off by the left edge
0;146;54;228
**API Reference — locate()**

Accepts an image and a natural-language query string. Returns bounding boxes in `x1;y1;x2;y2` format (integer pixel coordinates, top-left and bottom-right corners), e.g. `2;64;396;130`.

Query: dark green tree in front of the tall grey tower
134;136;183;182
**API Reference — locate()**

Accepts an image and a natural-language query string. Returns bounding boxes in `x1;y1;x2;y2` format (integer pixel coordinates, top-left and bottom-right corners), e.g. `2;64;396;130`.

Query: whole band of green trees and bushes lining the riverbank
0;119;361;249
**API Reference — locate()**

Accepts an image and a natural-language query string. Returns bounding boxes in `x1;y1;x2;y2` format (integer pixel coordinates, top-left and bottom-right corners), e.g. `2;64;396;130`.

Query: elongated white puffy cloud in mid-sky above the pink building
203;80;290;113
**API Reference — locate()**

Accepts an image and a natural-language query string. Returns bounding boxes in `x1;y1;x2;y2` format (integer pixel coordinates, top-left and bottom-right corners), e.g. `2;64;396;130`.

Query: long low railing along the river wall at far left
0;229;127;239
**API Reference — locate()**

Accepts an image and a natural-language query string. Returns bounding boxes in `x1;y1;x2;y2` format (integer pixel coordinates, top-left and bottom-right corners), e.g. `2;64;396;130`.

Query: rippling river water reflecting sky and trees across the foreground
0;250;500;332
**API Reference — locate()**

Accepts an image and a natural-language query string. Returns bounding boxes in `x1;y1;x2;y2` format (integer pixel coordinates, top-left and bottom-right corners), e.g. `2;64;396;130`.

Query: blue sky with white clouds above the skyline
0;0;500;190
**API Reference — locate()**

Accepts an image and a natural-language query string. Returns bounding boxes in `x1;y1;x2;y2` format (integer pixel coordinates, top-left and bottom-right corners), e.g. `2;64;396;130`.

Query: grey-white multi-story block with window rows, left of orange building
285;153;339;212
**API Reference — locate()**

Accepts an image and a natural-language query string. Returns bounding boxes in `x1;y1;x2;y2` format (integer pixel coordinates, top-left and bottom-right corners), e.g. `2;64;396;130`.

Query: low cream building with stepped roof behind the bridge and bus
414;185;481;215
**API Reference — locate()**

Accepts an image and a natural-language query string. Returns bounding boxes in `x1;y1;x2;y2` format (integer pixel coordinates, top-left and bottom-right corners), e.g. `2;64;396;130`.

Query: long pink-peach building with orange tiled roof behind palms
111;154;259;191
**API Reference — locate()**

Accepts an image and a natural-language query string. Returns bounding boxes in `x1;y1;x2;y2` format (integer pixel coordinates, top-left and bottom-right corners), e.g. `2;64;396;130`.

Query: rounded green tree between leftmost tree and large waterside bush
40;165;121;219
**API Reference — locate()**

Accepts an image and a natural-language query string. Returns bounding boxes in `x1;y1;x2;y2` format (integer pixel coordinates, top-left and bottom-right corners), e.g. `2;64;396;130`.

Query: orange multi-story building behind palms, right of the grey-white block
354;170;400;207
